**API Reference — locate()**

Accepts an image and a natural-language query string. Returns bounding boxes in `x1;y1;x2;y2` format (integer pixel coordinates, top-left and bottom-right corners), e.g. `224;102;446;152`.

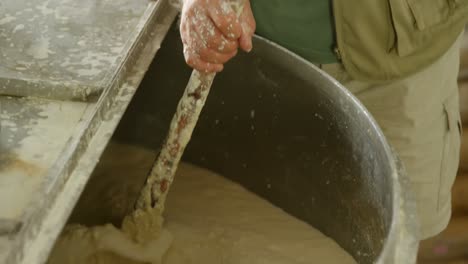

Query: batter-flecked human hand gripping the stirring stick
180;0;255;72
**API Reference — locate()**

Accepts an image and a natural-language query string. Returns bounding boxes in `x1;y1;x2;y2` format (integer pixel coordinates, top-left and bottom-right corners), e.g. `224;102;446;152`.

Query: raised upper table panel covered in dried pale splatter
0;0;149;99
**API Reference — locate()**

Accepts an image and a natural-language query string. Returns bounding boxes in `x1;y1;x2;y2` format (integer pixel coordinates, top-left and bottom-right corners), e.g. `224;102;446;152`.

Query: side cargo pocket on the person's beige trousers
437;97;462;209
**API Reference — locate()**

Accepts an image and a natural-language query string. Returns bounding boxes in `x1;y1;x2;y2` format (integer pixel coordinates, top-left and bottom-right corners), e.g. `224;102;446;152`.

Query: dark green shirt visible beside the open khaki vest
251;0;338;64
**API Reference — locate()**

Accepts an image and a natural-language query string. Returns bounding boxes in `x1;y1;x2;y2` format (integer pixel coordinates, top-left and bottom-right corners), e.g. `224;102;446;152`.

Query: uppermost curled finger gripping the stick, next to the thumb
208;1;242;40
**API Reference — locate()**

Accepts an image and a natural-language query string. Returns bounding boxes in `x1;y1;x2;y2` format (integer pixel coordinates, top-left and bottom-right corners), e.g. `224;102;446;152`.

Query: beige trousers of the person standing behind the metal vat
320;34;461;240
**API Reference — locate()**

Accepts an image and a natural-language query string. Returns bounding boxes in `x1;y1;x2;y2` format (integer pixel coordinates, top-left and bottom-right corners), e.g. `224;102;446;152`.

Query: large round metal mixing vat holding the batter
66;25;417;264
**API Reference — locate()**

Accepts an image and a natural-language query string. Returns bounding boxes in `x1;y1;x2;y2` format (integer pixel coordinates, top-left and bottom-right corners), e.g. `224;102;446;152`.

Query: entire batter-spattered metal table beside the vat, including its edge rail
0;0;177;264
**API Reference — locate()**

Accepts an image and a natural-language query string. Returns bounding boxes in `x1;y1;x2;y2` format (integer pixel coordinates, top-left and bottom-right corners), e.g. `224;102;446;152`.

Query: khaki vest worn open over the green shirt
333;0;468;81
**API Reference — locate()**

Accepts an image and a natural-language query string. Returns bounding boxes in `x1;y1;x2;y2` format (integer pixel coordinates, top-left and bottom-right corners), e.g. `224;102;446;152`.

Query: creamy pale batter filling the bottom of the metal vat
49;145;356;264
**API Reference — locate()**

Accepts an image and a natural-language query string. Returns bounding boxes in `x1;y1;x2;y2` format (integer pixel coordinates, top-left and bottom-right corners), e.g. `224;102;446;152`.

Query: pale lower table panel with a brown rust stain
0;97;90;225
